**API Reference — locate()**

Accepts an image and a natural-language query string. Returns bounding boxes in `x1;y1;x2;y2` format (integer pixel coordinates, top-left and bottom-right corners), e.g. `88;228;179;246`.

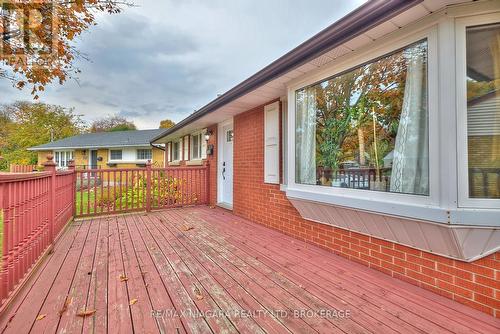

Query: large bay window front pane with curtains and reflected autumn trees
295;40;429;195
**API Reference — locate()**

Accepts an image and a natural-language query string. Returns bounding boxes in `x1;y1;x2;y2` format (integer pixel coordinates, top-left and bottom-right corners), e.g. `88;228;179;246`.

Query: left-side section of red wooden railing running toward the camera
0;160;74;303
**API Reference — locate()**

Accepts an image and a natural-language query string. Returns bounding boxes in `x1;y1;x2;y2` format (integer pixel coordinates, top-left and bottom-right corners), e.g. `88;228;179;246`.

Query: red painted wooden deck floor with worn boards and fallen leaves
0;207;500;334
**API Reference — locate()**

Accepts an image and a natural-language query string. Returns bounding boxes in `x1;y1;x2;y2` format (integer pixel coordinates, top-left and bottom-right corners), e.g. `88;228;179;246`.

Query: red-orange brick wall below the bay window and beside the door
228;101;500;318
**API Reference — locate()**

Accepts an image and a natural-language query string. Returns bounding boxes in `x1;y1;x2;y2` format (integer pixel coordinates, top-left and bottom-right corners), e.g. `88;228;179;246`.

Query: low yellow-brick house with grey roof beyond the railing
28;129;165;169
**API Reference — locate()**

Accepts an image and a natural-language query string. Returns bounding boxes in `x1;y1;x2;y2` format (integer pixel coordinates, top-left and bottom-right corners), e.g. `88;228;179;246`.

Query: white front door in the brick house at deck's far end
218;122;233;207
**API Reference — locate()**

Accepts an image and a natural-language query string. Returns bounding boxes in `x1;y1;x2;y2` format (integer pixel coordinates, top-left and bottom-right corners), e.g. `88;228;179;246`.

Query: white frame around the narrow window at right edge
455;13;500;208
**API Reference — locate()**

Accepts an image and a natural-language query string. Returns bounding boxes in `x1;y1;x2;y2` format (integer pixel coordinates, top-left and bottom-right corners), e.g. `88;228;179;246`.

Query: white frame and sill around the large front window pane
286;15;500;226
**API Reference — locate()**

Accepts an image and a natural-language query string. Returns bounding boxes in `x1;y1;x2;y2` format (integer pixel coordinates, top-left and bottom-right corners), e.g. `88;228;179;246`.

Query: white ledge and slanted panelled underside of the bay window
287;187;500;262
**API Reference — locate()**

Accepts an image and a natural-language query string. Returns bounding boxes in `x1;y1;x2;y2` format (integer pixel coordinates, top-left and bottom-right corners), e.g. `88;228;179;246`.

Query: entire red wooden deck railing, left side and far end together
0;156;209;306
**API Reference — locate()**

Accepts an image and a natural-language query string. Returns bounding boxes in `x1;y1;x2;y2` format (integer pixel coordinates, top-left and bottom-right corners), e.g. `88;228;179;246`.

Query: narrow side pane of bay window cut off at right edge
466;23;500;199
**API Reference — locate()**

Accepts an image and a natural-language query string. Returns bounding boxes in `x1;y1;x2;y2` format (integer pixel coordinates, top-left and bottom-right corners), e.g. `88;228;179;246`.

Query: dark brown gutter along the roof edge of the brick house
151;0;423;143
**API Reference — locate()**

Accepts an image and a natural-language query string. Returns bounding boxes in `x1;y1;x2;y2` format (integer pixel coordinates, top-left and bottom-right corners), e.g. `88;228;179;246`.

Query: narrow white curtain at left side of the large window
295;88;316;184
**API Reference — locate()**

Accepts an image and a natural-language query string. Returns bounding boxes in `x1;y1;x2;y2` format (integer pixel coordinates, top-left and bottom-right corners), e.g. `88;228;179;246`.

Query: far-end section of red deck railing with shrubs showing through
76;163;208;217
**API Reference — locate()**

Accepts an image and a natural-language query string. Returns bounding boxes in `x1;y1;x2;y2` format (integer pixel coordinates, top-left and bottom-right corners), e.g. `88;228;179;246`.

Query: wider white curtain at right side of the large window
390;45;429;195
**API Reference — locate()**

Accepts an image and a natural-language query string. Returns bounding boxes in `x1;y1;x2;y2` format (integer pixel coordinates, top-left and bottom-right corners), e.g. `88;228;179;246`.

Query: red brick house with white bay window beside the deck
152;0;500;316
